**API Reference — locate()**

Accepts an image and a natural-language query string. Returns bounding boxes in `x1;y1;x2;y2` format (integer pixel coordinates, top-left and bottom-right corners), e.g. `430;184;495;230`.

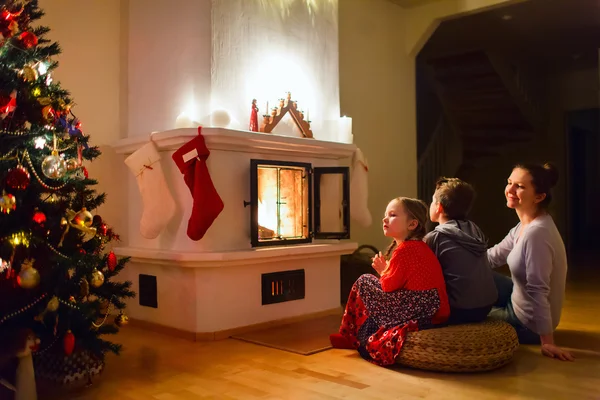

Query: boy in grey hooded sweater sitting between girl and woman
424;178;498;324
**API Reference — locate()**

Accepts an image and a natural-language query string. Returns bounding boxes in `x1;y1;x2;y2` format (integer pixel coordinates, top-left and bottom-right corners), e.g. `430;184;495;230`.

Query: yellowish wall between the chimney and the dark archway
339;0;417;250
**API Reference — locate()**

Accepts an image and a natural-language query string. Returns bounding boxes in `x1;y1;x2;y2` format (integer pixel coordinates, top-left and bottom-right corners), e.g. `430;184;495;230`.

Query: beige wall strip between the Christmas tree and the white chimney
39;0;126;238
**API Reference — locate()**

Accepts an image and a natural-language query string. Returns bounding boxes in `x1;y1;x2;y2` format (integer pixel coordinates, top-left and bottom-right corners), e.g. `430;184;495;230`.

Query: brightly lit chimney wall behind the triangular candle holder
211;0;340;140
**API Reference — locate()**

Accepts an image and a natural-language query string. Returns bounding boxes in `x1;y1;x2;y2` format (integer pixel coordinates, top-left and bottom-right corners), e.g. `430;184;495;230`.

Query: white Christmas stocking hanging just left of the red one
125;142;176;239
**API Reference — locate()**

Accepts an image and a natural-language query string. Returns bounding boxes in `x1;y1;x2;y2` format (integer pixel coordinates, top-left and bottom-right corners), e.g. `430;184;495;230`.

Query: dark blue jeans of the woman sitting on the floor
489;271;540;344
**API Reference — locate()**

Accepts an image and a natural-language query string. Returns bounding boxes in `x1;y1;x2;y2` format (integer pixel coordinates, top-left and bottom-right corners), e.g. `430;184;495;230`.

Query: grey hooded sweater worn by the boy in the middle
425;220;498;309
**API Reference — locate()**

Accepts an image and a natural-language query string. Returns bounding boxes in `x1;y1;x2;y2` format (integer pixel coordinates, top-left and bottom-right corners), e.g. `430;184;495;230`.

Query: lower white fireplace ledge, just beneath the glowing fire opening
113;242;357;268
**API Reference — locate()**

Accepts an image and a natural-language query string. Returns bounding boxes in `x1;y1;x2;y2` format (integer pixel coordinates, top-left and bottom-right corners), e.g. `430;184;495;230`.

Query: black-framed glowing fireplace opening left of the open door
251;160;312;246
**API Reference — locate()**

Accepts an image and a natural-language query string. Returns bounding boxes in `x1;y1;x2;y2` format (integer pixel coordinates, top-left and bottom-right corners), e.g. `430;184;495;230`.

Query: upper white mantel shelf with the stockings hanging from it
113;128;356;159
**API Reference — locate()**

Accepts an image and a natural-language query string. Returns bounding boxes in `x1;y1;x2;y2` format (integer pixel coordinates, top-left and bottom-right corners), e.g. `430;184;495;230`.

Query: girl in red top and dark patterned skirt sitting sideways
330;197;450;365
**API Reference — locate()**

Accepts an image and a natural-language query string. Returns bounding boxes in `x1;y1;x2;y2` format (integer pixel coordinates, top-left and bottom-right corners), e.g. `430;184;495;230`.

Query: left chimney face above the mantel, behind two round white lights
124;0;211;137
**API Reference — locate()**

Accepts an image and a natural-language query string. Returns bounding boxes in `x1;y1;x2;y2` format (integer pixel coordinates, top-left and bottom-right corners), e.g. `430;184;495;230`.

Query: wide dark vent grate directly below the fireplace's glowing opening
262;269;306;305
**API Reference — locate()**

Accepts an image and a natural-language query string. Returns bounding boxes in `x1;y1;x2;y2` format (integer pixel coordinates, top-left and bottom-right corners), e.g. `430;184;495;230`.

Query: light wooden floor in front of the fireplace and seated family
41;263;600;400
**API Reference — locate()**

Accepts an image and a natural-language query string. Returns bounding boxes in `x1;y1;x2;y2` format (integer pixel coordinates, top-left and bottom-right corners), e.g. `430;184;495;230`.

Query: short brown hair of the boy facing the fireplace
434;177;475;220
